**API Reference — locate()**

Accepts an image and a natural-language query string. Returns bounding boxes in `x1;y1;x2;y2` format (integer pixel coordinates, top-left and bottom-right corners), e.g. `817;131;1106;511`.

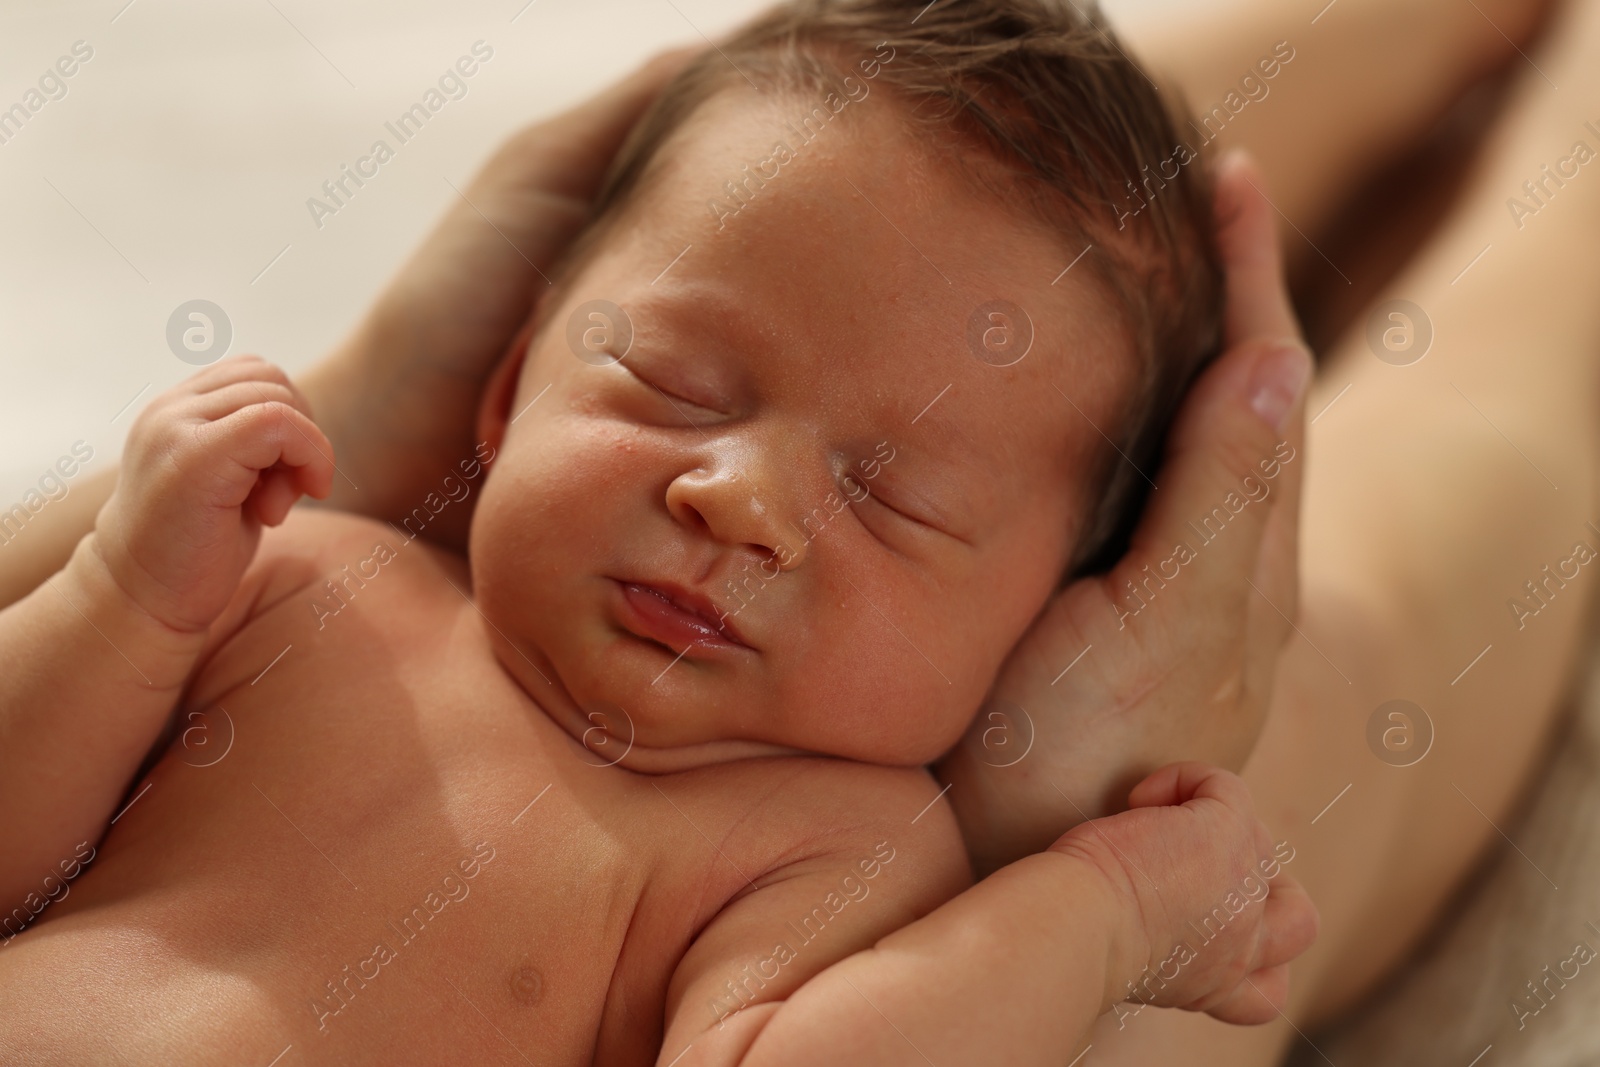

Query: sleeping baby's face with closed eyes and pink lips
470;88;1131;769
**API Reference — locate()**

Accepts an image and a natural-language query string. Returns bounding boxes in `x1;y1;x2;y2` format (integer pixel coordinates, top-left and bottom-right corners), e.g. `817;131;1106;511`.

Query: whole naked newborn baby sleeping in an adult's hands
0;0;1309;1065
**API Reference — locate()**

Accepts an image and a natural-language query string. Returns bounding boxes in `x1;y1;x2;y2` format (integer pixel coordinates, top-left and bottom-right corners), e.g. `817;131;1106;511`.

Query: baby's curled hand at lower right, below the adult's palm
1051;763;1317;1024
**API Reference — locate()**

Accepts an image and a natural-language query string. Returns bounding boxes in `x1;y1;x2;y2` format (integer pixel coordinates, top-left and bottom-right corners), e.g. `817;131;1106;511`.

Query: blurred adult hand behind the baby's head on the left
298;50;693;547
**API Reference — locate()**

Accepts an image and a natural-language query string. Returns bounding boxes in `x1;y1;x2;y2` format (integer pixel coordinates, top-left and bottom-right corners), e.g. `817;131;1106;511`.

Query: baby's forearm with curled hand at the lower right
659;763;1317;1067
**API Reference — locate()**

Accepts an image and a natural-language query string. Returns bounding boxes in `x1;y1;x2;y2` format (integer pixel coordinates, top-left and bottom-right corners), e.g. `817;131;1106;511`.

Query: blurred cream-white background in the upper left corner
0;0;940;499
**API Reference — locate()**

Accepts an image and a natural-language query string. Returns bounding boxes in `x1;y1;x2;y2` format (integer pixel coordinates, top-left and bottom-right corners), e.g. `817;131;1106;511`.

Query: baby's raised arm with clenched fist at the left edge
0;357;333;912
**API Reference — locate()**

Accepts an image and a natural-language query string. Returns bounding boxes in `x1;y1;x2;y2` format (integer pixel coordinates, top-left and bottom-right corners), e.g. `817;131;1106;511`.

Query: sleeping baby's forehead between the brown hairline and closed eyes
556;79;1134;470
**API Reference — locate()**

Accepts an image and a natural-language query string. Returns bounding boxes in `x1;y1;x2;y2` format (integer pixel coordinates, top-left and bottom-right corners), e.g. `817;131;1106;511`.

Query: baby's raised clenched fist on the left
94;355;333;633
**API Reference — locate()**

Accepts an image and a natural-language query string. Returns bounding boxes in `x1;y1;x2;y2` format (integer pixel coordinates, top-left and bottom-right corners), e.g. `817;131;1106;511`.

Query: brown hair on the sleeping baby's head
568;0;1222;577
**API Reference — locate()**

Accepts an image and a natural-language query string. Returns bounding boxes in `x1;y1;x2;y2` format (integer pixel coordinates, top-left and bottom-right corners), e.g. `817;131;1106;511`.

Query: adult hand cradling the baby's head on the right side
936;155;1312;875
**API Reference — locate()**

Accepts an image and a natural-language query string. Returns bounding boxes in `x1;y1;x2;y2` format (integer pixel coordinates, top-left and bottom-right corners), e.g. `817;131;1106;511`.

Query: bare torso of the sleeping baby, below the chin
0;515;872;1065
